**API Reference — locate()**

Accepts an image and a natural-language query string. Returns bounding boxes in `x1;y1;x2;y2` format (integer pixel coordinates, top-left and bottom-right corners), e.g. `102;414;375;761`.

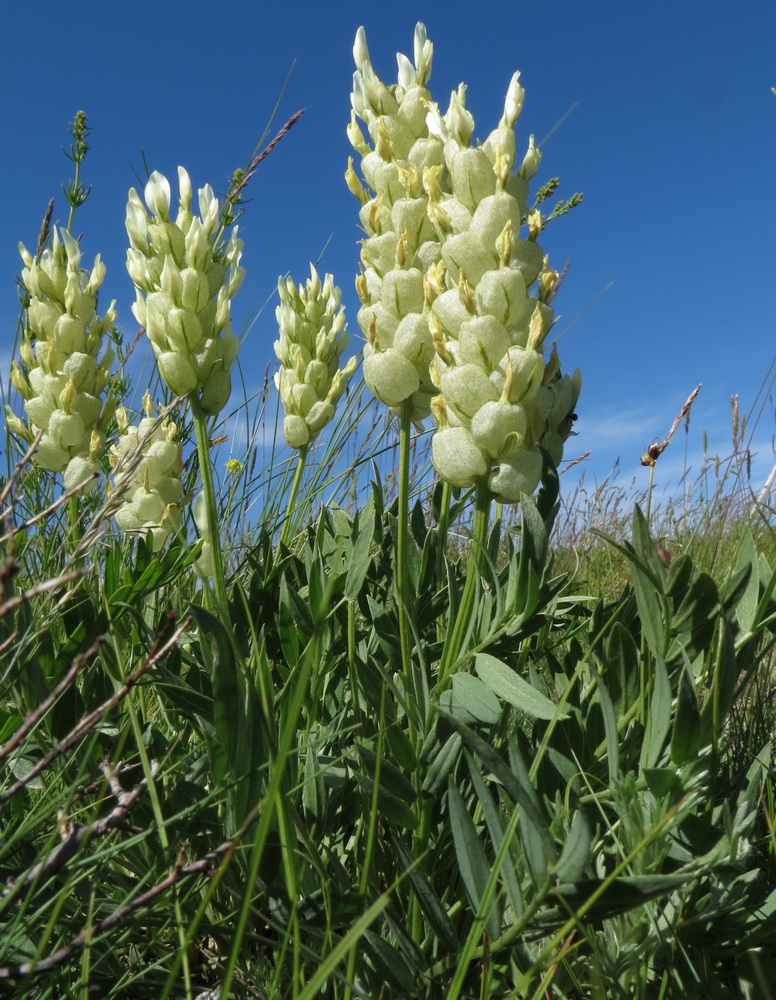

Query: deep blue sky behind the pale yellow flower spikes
0;0;776;500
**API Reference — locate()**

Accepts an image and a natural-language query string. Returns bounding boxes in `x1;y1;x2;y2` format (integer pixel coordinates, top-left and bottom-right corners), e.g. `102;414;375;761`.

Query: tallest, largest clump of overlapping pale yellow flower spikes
346;24;581;502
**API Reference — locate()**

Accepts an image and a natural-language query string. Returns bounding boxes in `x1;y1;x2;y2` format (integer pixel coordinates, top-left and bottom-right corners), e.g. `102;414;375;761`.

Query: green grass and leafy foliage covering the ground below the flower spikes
0;386;776;998
